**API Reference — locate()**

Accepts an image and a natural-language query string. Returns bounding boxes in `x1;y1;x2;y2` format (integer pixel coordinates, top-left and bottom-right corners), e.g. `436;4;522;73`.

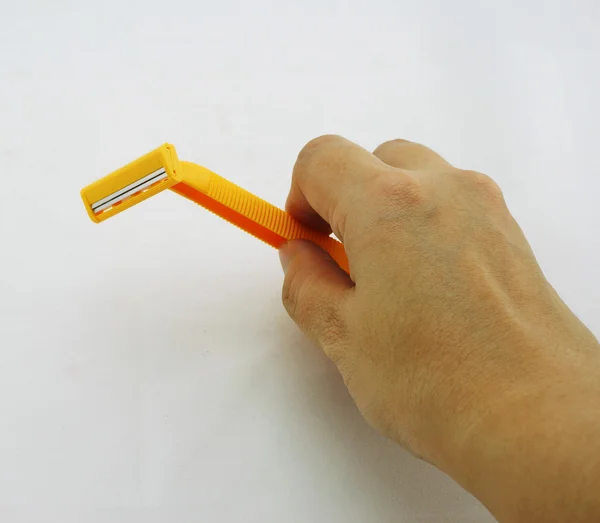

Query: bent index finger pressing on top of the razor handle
285;135;389;241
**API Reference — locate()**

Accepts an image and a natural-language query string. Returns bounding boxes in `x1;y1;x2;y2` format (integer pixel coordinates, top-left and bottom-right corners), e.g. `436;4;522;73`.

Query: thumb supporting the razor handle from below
279;240;354;356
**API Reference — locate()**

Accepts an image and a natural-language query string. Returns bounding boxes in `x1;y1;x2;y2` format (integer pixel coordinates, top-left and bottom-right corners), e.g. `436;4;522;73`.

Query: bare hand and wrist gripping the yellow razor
280;136;600;523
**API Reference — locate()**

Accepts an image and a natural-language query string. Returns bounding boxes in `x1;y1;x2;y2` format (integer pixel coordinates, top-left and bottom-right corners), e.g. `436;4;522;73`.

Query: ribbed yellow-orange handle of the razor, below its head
172;173;349;272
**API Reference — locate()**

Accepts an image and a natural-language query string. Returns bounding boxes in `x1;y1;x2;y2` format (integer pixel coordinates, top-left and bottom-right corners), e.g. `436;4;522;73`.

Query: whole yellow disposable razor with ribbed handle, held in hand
81;144;349;272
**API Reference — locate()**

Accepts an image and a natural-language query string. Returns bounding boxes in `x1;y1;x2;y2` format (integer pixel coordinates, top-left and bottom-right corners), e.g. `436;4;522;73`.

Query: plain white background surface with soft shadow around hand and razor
0;0;600;523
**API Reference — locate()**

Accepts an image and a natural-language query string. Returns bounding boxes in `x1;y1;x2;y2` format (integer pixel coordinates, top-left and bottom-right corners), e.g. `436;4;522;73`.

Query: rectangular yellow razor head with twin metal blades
81;144;183;223
